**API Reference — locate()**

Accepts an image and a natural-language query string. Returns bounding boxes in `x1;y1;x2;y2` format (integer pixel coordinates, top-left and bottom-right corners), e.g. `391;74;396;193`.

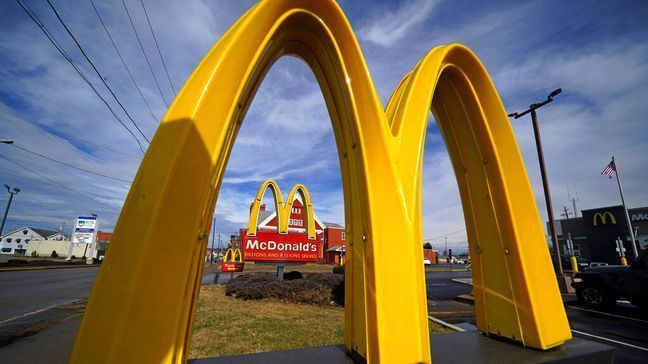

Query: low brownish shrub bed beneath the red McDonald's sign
225;273;344;305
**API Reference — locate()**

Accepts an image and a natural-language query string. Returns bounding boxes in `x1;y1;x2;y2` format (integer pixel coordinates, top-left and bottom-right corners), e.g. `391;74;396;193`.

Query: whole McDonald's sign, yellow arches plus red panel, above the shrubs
241;180;323;262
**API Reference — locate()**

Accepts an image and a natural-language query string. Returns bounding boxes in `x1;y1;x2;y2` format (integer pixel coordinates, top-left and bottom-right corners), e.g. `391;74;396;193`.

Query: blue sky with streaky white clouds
0;0;648;250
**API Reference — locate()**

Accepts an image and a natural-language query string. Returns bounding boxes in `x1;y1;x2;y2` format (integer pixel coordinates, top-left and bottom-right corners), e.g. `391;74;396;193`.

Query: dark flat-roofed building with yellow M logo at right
556;205;648;264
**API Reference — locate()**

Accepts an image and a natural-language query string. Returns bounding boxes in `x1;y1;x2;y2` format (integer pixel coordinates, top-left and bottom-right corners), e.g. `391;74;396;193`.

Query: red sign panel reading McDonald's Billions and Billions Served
241;229;322;262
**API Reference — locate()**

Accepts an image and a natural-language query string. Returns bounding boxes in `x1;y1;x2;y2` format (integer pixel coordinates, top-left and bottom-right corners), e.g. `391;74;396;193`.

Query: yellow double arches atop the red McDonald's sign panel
247;180;317;240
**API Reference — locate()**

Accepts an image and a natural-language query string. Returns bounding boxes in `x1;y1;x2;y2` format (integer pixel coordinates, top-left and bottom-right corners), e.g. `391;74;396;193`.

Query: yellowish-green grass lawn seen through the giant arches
189;284;448;358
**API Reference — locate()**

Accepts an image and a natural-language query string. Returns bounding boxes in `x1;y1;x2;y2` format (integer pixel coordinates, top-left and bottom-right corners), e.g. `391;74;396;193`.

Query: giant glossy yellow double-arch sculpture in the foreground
71;0;571;363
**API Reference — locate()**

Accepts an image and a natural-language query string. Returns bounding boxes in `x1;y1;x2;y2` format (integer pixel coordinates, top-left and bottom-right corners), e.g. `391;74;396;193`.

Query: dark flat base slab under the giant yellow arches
190;332;616;364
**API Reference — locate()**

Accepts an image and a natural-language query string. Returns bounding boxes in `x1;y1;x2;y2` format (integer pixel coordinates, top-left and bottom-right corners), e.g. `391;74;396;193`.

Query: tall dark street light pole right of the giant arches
508;89;563;277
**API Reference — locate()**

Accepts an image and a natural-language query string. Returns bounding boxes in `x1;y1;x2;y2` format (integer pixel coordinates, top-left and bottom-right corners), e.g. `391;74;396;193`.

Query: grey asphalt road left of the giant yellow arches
0;267;99;321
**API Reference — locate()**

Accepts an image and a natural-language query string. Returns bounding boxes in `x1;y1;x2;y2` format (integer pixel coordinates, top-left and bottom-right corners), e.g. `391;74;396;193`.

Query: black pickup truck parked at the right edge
572;249;648;313
